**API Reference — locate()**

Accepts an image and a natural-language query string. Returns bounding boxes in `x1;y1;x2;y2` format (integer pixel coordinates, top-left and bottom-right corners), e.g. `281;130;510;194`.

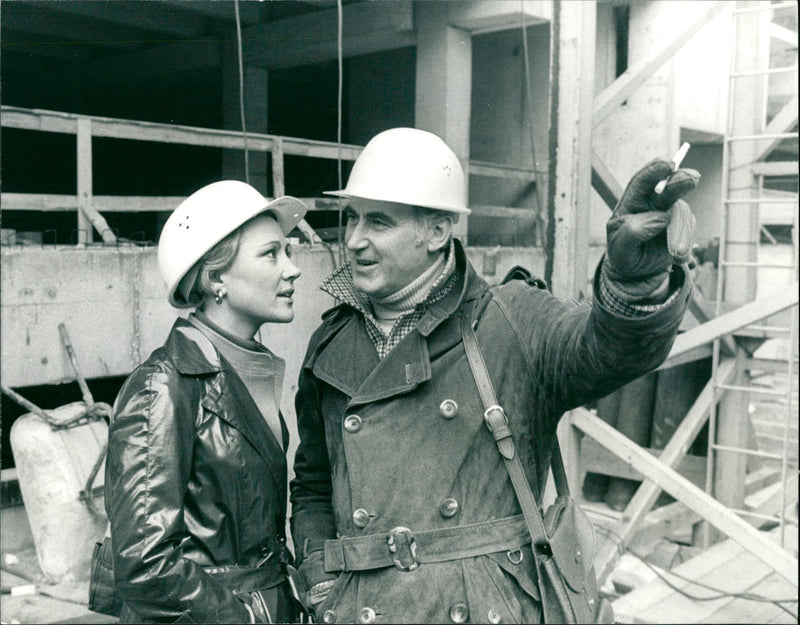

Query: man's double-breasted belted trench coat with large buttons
291;245;691;623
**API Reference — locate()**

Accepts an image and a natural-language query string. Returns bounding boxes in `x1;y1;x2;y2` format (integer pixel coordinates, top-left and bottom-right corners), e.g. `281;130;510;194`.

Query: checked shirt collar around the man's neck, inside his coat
320;241;458;360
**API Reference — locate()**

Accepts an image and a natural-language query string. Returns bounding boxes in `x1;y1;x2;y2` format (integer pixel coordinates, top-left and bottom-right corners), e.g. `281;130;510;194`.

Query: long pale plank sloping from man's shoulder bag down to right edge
570;409;798;586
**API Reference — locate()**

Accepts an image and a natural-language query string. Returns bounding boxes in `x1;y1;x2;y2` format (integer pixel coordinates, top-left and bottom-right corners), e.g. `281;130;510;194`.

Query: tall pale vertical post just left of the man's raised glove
545;2;596;298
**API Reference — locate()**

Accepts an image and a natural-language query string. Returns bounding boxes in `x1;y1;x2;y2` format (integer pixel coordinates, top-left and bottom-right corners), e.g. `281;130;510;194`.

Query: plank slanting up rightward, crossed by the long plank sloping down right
594;360;735;582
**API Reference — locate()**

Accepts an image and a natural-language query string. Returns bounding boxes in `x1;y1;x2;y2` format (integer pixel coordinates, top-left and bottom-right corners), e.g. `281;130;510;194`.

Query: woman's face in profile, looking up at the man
219;215;300;330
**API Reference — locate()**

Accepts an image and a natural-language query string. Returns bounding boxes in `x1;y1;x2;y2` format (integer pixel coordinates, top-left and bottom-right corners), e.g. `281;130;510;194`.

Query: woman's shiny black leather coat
105;319;289;623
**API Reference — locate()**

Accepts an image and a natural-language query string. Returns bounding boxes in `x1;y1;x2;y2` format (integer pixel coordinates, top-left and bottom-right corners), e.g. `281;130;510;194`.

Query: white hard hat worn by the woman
158;180;306;308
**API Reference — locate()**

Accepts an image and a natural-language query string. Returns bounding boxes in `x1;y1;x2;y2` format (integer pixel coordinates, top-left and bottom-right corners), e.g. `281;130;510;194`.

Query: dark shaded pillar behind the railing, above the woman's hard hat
222;41;268;194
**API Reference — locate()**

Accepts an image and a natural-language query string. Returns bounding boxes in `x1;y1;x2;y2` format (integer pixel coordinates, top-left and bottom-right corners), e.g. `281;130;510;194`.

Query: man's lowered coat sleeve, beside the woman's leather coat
291;332;336;588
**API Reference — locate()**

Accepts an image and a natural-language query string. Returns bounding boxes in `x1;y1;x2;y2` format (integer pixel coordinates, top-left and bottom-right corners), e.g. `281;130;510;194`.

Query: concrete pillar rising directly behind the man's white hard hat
414;2;472;239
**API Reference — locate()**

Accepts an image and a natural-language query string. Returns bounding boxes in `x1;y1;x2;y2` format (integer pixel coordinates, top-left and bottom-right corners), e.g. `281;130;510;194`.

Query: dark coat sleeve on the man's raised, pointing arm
495;258;691;413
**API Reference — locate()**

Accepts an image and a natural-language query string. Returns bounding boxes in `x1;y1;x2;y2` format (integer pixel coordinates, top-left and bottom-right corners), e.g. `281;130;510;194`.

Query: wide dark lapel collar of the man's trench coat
309;241;487;405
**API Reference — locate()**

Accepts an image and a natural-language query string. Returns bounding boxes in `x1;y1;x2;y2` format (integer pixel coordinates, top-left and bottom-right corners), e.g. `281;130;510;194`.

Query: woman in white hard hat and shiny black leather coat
105;180;306;623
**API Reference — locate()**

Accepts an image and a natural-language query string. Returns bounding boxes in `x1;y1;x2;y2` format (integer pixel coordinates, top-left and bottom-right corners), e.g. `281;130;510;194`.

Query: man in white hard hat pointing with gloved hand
291;128;696;623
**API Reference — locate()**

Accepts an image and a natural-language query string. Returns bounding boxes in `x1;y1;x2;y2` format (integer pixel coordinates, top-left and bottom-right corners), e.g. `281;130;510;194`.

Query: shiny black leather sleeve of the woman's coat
105;363;250;623
